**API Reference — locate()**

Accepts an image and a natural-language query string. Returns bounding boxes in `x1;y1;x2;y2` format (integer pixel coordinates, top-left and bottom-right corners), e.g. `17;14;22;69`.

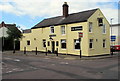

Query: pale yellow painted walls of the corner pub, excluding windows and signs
20;9;110;56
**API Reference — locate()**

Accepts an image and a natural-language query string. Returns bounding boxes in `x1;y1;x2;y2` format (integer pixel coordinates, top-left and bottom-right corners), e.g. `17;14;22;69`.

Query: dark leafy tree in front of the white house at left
4;26;22;50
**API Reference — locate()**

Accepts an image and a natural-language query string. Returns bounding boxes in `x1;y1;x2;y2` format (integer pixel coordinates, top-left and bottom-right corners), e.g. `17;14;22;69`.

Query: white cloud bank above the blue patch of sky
0;0;118;23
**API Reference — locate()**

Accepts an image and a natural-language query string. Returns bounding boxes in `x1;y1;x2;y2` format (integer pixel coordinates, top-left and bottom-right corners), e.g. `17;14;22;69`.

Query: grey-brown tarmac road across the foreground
2;54;118;79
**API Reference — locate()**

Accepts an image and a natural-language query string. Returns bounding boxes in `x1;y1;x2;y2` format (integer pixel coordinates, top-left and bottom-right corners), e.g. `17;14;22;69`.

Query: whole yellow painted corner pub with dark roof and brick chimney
20;3;110;56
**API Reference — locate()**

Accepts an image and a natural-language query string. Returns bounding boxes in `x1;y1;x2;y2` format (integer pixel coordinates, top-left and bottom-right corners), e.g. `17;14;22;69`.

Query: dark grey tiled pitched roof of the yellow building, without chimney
32;9;98;29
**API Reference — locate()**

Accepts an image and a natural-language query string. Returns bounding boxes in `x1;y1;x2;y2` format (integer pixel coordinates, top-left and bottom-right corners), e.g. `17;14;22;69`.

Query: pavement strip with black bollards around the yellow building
3;51;120;60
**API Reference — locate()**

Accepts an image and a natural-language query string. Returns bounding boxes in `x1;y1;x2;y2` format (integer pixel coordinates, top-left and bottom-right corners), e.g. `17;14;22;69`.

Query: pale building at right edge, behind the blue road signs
110;24;120;45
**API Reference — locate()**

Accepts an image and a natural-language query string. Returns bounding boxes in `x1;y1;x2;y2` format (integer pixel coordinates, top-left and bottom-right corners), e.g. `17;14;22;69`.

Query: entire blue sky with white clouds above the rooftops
0;0;120;29
